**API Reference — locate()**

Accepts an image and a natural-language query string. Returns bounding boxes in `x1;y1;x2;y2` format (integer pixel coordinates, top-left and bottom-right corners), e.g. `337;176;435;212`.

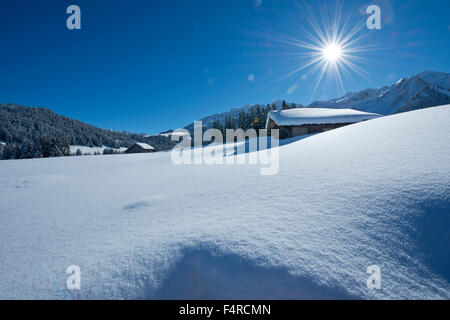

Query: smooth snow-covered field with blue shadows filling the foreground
0;106;450;299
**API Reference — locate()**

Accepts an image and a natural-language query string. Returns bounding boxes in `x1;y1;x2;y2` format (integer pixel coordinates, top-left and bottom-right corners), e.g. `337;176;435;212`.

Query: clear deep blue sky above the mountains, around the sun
0;0;450;133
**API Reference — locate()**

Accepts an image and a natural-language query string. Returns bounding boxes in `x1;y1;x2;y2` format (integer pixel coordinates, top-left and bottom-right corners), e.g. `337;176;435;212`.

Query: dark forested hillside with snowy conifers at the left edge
0;104;175;159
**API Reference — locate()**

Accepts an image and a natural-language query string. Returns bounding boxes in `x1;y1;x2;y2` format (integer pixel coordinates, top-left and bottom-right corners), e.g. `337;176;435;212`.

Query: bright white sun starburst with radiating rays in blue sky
265;1;376;99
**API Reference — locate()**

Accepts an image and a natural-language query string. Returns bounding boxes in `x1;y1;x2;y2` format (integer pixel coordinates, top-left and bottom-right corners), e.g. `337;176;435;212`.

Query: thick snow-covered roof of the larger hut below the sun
267;108;381;126
